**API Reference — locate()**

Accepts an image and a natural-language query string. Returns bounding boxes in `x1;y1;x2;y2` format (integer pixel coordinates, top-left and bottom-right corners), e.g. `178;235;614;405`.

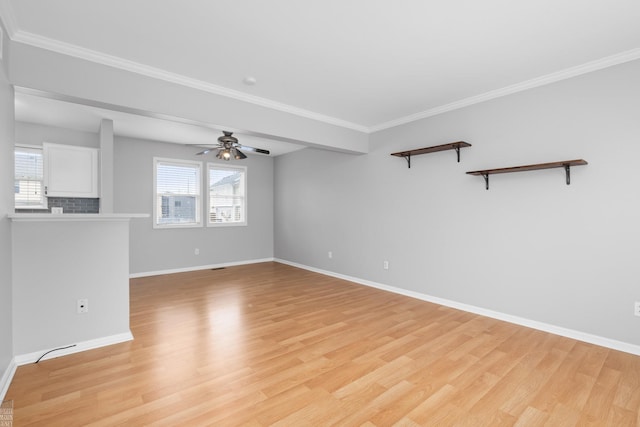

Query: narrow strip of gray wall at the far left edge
0;25;14;400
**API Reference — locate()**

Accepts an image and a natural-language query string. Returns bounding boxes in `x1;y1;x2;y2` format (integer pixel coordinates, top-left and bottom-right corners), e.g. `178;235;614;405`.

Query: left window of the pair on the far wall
153;158;202;228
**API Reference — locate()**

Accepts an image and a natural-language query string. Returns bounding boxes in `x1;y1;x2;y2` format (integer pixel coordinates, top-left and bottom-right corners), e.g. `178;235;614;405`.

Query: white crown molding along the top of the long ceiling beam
10;29;369;133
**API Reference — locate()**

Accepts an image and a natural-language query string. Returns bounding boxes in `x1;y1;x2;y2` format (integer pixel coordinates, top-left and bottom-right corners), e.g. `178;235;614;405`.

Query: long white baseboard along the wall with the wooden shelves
275;258;640;356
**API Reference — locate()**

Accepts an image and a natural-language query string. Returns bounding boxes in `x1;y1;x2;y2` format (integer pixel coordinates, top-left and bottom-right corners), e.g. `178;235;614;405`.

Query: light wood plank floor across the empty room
6;263;640;427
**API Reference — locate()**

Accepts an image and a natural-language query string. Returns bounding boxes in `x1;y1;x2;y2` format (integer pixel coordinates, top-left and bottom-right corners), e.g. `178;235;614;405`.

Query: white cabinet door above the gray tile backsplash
42;142;98;197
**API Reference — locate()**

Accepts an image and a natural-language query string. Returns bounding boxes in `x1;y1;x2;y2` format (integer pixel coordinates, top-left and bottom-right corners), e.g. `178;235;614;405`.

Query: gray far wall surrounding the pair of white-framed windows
114;137;273;274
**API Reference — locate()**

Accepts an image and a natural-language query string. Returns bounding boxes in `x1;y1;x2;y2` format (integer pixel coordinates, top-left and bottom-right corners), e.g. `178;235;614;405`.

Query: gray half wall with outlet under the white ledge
12;220;130;356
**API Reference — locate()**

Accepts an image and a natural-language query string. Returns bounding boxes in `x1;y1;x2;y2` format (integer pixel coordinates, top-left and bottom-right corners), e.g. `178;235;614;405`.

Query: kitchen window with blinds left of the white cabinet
14;145;47;209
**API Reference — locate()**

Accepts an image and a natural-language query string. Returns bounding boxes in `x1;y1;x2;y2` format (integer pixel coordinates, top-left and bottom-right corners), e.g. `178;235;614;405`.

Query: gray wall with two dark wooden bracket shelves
275;61;640;345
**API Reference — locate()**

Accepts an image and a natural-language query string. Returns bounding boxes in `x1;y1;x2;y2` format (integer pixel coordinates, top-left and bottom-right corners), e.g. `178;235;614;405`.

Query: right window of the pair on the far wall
207;163;247;226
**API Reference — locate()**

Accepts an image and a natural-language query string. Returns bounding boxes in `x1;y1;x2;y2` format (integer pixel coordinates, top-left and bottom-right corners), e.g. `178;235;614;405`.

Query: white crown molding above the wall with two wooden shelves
369;48;640;133
